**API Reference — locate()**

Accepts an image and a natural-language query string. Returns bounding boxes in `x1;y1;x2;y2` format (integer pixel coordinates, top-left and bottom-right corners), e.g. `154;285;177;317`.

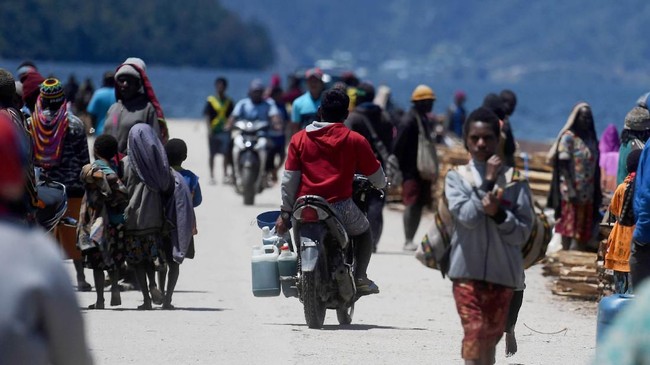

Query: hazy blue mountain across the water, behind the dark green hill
221;0;650;81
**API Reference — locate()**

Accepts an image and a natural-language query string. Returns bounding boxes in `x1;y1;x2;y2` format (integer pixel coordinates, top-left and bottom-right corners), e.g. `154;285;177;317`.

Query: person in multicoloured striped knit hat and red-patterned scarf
27;78;92;291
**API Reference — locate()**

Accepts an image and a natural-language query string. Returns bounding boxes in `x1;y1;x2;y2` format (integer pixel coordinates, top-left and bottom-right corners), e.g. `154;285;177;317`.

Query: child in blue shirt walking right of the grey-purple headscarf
158;138;197;310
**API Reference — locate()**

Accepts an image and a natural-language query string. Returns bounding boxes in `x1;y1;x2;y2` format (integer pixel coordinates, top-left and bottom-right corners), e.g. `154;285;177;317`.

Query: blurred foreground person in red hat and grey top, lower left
0;113;92;365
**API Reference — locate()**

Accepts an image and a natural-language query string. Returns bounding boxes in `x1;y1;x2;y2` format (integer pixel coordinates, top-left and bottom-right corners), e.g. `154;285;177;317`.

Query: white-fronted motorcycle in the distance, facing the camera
233;120;269;205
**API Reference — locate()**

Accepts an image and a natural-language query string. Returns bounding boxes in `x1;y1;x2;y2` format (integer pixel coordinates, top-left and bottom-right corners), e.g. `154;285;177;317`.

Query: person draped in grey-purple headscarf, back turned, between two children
122;123;174;310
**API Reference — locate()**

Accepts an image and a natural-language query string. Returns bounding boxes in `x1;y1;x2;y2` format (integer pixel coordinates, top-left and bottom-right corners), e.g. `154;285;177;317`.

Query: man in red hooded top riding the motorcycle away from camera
276;89;386;295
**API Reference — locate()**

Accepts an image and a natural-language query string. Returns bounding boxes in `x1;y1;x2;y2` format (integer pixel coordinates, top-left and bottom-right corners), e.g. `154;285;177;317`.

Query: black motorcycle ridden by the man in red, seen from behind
283;175;383;328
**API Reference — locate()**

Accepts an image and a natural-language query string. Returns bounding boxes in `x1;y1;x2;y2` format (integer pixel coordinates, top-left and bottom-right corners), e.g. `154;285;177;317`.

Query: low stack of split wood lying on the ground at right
543;250;602;300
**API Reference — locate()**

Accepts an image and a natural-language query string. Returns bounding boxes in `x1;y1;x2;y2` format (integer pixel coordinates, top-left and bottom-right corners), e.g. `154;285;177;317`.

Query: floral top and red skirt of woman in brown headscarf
555;130;600;242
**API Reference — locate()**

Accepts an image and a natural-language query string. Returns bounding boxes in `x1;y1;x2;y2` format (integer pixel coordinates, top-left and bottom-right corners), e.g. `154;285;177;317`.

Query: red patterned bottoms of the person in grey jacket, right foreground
453;279;512;360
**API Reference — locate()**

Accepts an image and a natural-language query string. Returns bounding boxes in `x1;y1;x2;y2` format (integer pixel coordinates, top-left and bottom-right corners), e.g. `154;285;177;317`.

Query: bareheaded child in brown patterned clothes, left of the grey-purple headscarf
77;134;128;309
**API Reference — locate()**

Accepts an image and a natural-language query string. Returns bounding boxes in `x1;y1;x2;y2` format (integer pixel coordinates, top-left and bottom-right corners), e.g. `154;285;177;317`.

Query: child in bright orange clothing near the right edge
604;150;642;294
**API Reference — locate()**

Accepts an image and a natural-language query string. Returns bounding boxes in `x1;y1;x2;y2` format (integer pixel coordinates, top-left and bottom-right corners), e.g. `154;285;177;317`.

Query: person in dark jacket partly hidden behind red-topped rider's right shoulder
345;82;393;252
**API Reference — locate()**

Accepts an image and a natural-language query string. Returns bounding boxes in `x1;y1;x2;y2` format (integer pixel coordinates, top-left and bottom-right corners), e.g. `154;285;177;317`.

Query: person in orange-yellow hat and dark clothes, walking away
393;85;437;251
